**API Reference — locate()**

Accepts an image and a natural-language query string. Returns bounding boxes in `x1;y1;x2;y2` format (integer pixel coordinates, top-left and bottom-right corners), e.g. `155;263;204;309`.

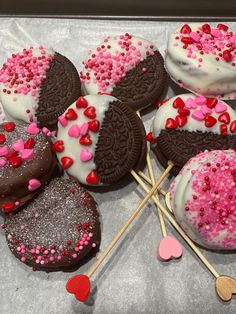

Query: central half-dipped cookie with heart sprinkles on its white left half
53;95;146;185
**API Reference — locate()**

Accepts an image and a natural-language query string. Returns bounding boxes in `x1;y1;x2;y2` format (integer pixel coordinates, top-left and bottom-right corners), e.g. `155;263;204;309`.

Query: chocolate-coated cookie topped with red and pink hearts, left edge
0;122;56;213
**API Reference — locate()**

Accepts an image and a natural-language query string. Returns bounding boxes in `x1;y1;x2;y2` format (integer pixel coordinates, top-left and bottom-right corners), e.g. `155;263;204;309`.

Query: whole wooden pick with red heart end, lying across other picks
66;163;173;302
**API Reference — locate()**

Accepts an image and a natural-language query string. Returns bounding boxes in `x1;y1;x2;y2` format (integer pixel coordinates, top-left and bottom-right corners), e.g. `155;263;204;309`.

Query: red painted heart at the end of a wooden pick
66;275;90;302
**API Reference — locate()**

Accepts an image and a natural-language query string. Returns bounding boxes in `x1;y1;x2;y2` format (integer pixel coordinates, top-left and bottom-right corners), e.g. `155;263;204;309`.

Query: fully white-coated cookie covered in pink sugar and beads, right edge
170;150;236;250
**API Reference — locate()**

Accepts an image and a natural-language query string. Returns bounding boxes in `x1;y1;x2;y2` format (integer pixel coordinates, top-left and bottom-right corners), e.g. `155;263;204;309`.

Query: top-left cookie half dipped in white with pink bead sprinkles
0;47;81;130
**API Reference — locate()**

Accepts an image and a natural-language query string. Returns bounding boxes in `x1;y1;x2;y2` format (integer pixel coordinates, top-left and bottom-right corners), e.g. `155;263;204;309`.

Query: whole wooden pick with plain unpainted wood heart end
131;174;236;301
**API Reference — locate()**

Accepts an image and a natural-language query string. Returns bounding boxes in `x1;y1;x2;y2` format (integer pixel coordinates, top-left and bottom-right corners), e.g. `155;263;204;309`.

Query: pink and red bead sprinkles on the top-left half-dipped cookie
0;46;53;98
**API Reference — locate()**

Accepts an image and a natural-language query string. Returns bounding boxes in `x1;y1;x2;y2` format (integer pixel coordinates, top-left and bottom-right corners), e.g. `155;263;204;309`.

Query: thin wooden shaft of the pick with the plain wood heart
132;173;220;278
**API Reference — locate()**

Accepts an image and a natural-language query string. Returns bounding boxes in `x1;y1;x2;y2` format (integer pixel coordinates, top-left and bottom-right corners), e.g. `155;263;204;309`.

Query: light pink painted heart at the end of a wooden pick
157;236;183;261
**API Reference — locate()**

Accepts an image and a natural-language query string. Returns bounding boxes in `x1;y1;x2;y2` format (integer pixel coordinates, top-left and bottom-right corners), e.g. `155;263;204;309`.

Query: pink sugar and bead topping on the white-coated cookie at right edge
185;151;236;249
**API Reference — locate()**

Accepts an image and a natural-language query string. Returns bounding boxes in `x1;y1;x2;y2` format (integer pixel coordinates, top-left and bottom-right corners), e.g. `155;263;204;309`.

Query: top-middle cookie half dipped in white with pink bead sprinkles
80;33;167;110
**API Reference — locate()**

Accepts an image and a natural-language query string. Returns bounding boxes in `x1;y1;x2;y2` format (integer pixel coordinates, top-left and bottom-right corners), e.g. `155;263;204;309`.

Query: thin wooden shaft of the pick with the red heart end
87;163;173;278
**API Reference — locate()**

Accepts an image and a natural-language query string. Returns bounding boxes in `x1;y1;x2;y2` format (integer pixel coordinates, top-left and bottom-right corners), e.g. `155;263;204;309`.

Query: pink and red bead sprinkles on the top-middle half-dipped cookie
80;33;154;93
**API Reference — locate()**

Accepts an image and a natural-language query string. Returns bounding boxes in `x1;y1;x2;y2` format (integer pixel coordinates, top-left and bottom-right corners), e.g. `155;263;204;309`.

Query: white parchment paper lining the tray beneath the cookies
0;17;236;314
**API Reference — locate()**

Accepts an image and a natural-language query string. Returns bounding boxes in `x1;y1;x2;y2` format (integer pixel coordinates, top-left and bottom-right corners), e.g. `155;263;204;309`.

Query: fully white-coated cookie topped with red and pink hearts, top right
165;23;236;100
